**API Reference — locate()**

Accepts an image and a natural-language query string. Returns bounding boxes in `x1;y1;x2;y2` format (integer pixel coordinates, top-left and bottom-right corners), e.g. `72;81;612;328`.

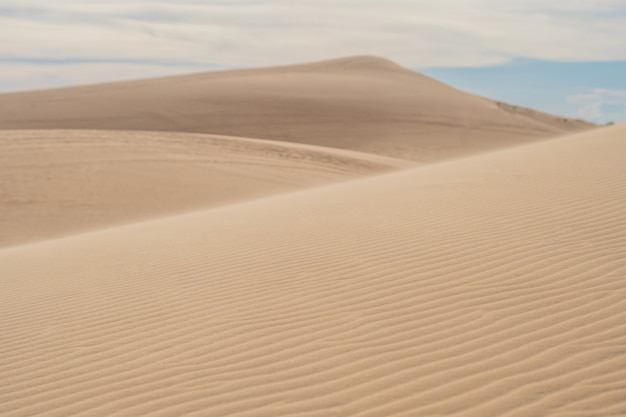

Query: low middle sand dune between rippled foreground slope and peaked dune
0;130;409;246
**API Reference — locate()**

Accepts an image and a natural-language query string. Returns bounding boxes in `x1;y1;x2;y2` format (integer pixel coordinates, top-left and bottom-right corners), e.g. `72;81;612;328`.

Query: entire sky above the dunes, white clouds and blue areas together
0;0;626;123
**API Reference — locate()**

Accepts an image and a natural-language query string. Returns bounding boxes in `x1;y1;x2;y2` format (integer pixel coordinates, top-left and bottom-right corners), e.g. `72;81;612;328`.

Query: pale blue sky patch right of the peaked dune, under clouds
418;59;626;123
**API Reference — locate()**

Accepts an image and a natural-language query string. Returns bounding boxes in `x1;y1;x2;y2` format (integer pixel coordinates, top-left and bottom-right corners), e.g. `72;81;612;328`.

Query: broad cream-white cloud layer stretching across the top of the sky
0;0;626;89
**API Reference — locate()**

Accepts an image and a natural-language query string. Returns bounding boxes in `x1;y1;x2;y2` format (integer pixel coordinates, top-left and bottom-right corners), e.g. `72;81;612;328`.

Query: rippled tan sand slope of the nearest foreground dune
0;122;626;417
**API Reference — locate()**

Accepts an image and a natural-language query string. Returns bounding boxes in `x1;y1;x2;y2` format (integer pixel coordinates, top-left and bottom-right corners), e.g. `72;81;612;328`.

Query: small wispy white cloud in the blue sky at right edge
568;88;626;123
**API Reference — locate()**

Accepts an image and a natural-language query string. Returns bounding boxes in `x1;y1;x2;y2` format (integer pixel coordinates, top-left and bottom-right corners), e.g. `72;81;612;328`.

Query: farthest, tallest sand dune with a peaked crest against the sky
0;57;591;162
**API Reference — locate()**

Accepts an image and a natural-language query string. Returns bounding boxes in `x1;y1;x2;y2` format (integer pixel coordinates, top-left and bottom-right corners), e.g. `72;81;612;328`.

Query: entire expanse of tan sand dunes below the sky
0;57;626;417
